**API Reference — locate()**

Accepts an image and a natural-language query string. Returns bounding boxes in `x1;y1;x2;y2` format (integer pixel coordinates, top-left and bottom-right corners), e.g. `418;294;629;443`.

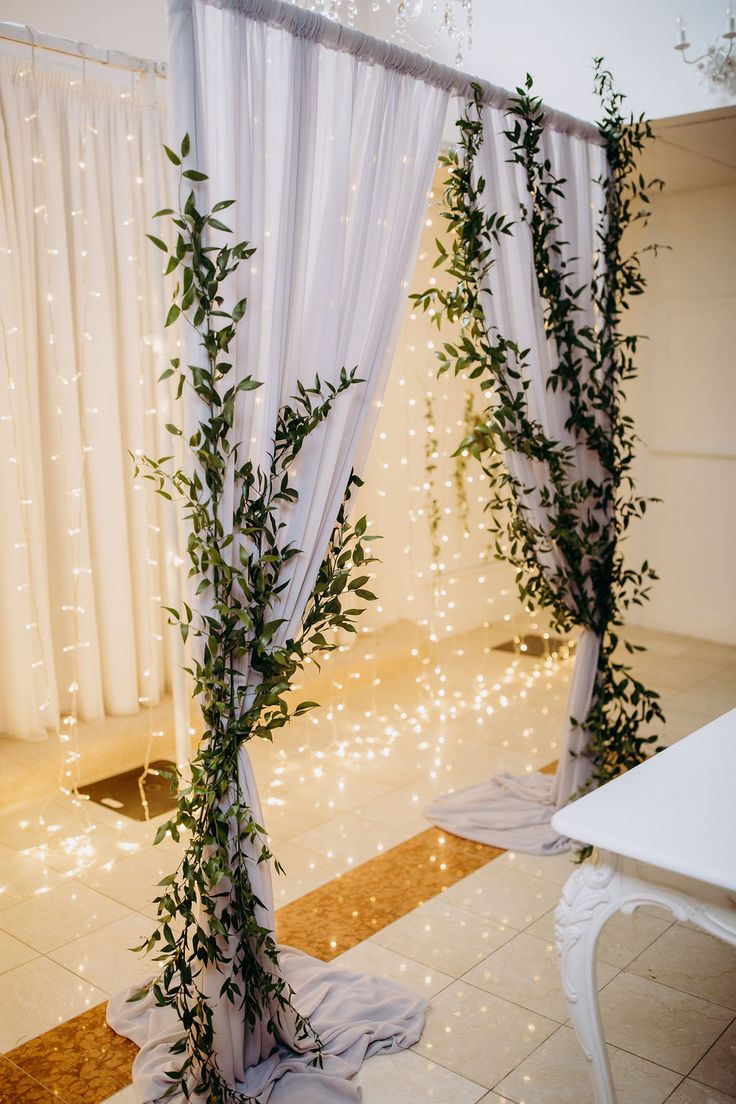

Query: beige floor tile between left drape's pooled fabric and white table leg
414;981;557;1089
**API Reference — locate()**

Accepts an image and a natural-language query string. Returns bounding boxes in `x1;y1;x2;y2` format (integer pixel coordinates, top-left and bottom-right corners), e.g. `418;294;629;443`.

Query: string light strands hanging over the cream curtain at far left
0;35;183;873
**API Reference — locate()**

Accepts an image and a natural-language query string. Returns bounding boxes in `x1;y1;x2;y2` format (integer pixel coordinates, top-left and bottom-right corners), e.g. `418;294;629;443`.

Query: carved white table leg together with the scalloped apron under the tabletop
555;851;736;1104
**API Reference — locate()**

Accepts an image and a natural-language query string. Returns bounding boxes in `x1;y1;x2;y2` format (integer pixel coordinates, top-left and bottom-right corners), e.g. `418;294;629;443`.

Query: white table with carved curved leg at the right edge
552;709;736;1104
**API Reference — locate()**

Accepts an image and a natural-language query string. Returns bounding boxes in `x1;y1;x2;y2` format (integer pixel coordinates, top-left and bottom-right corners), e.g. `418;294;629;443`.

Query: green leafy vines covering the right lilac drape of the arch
413;59;663;834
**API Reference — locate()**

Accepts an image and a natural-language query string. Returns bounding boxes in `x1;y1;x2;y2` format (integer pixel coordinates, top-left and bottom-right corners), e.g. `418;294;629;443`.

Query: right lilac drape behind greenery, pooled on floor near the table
425;106;608;854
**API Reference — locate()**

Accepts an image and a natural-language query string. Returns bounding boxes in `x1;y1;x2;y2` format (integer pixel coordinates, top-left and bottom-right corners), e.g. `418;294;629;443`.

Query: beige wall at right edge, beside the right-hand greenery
630;185;736;644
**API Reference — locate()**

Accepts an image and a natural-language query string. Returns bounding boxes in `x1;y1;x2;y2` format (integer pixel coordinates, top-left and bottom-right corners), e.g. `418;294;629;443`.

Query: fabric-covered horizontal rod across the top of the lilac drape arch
197;0;604;145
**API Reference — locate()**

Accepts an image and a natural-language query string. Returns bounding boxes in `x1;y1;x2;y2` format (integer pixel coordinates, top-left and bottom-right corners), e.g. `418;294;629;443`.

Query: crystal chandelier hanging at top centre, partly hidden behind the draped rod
295;0;472;65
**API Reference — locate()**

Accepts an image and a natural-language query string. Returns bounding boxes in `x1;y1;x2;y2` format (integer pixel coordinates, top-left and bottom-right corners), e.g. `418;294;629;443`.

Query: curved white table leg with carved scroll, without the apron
555;862;621;1104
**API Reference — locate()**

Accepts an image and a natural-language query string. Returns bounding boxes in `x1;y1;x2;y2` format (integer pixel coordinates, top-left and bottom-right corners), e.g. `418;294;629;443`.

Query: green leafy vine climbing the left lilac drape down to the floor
131;137;384;1104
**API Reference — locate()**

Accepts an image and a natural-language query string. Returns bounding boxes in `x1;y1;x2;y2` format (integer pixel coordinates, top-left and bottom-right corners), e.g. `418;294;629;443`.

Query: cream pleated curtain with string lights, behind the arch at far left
0;47;180;739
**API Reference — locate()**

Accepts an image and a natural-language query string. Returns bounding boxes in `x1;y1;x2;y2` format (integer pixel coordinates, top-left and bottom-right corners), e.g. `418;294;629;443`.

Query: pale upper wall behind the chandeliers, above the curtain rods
5;0;735;118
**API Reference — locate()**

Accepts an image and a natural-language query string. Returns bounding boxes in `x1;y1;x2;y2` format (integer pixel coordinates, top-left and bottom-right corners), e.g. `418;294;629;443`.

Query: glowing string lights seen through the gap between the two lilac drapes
270;174;569;834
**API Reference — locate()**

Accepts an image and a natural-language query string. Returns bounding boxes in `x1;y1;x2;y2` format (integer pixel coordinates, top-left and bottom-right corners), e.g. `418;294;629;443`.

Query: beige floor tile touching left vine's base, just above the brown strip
49;913;159;996
